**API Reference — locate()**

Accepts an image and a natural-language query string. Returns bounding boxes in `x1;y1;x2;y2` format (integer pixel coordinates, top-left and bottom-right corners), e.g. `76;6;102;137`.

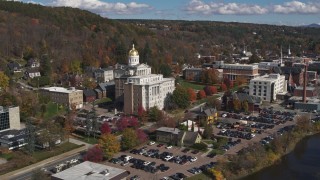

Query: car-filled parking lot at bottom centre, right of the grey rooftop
105;144;216;179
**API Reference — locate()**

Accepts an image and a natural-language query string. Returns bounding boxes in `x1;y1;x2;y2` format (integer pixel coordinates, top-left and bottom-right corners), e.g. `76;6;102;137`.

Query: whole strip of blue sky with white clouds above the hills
18;0;320;26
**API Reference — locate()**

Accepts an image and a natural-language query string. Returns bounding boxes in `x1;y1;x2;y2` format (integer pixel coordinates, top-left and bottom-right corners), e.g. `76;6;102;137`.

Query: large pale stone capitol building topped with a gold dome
114;45;175;114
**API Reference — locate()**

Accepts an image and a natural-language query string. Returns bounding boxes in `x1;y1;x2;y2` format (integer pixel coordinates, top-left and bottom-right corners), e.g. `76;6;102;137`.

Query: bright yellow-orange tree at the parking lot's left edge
99;134;120;159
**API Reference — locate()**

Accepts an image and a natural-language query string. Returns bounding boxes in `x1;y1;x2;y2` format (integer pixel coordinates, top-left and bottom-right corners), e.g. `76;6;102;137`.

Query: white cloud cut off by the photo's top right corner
273;1;320;14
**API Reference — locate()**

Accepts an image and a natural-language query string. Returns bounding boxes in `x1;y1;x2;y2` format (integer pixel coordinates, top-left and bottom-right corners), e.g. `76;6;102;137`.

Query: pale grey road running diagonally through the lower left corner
0;146;87;179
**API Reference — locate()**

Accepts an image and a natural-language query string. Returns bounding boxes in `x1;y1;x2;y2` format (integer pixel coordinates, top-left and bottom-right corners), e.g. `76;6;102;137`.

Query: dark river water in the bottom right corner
242;134;320;180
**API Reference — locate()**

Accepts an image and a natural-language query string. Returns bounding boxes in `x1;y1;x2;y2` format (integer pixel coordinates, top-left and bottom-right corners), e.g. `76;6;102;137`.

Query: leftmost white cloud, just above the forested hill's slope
48;0;152;15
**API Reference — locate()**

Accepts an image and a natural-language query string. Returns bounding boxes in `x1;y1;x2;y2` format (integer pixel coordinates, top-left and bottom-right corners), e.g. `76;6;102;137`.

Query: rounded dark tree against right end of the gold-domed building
172;86;190;109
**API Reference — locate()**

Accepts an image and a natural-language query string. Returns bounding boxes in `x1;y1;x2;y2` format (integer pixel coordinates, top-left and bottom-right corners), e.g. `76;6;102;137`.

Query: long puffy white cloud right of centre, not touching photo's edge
185;0;269;15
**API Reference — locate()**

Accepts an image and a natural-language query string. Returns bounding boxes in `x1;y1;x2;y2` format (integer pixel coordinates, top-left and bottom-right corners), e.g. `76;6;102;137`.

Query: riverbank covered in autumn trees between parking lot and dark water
216;118;320;179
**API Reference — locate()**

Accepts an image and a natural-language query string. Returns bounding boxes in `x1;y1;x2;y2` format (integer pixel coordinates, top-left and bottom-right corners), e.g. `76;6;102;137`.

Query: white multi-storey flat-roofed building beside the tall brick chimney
249;74;287;102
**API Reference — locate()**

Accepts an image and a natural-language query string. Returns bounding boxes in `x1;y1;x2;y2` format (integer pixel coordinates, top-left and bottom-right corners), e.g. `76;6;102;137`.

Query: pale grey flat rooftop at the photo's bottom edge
52;161;129;180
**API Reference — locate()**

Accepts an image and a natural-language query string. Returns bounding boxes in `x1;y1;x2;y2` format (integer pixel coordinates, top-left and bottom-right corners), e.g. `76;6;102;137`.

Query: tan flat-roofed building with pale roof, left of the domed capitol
40;87;83;109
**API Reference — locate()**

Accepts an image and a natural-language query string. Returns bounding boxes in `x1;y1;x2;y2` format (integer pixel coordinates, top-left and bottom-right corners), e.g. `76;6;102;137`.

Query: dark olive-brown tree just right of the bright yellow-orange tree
121;128;138;150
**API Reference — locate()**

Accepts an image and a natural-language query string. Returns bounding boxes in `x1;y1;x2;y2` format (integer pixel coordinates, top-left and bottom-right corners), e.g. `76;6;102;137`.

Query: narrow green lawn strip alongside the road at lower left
32;142;81;161
